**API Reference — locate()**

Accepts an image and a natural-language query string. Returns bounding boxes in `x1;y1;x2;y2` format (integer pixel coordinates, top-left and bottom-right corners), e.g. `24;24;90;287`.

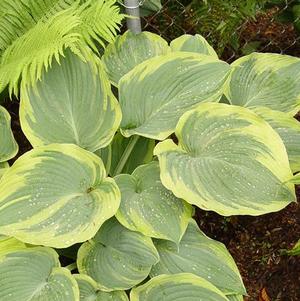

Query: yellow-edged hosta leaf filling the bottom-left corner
0;242;79;301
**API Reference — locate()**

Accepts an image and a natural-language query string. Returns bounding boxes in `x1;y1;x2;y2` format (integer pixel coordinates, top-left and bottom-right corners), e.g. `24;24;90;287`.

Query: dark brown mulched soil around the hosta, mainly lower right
4;101;300;301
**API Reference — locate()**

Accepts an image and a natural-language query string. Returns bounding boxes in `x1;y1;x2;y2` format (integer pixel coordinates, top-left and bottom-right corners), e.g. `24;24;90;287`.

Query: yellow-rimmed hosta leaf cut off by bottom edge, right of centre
130;273;228;301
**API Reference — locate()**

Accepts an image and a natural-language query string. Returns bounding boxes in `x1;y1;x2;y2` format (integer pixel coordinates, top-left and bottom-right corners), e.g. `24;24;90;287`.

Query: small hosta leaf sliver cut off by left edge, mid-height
0;106;18;163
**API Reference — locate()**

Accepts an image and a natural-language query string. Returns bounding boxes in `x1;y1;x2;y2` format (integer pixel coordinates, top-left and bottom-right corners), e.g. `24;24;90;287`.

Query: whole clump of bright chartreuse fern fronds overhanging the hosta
0;0;123;95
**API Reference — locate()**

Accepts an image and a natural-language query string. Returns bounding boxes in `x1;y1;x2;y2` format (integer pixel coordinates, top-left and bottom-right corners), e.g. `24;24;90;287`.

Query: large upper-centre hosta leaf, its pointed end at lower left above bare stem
119;52;230;140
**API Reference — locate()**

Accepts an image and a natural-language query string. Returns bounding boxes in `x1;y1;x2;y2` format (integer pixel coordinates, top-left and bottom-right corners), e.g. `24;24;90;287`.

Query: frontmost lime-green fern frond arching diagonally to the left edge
0;10;80;94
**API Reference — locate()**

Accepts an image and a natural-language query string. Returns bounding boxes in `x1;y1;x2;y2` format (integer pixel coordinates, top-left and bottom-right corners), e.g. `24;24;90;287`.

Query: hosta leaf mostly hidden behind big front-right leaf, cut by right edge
255;107;300;172
